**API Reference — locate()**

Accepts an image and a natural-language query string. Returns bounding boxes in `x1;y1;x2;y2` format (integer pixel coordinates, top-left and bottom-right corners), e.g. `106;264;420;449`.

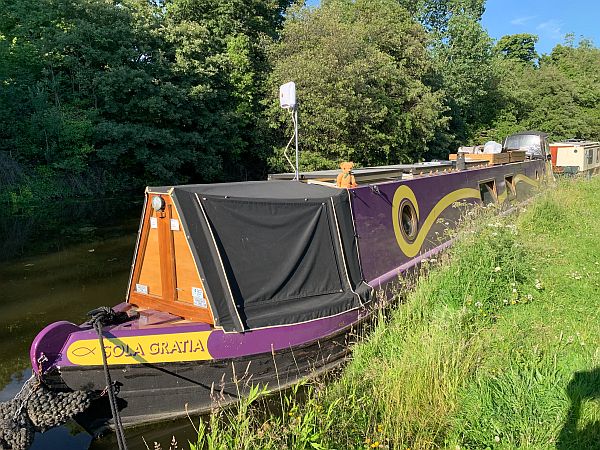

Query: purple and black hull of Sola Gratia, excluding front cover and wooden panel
30;160;547;432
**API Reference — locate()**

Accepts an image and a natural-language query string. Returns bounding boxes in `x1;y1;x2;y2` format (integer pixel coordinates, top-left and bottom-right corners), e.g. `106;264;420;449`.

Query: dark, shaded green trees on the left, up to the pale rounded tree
0;0;288;200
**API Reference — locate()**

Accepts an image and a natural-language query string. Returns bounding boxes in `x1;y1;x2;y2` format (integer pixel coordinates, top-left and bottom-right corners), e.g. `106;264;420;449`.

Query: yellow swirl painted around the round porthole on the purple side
392;185;480;258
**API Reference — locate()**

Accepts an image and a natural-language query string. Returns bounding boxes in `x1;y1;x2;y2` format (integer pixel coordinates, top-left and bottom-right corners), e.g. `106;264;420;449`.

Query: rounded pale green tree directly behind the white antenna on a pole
266;0;442;170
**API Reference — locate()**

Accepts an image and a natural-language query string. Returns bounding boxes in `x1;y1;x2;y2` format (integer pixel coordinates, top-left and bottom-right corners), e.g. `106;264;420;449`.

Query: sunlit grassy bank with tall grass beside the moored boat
180;178;600;449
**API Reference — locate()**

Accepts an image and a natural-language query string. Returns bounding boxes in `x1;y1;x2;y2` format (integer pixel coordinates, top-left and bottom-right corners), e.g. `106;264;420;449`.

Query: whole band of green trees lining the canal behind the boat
0;0;600;201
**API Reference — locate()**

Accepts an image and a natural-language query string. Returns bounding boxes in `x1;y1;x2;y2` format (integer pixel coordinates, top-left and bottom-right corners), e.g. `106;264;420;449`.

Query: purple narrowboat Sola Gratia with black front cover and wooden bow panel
30;133;548;432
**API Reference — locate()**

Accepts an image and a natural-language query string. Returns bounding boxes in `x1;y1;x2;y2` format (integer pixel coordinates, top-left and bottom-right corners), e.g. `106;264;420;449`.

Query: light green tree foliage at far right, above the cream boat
486;40;600;140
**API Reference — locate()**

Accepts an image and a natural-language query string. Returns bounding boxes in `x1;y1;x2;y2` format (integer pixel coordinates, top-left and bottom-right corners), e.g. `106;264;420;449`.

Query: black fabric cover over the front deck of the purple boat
165;181;371;331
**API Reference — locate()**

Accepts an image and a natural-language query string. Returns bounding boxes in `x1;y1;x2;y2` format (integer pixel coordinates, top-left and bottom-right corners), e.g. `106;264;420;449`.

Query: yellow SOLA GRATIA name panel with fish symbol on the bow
67;331;212;366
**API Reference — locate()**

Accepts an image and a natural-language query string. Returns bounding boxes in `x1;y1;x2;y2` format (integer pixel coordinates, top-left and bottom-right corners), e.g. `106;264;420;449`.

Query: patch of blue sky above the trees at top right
307;0;600;54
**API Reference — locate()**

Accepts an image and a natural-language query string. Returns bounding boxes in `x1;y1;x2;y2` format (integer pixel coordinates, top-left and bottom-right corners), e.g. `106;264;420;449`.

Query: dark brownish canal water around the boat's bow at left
0;200;198;450
